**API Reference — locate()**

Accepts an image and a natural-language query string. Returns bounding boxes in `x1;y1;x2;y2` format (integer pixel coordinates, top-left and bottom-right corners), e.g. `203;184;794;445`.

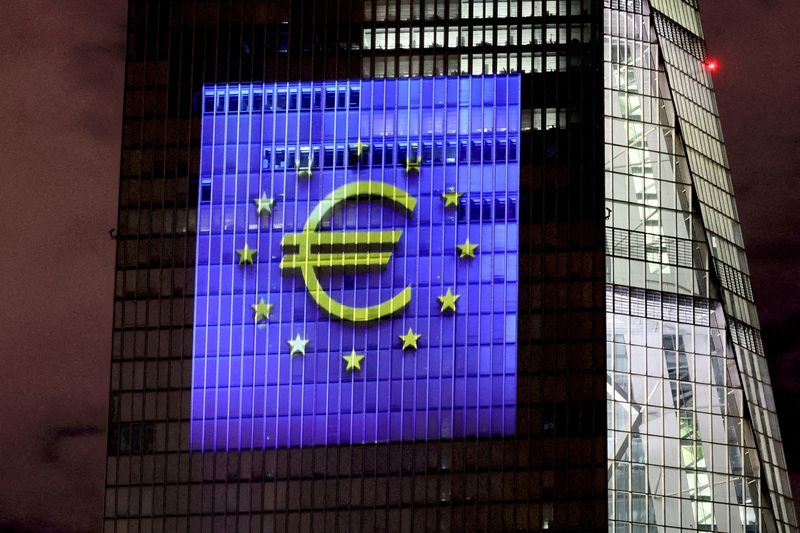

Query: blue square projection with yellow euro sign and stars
191;76;520;450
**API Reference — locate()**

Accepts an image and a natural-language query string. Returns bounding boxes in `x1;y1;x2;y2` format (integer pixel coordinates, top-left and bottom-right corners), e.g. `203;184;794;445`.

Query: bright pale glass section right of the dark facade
604;0;795;532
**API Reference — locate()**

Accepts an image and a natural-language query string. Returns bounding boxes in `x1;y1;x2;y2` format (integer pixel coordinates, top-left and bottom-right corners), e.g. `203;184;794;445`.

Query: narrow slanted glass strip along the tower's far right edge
654;8;797;531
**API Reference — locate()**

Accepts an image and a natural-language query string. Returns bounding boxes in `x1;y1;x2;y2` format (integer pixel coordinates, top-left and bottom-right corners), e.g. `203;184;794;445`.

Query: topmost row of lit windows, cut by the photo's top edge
364;0;592;21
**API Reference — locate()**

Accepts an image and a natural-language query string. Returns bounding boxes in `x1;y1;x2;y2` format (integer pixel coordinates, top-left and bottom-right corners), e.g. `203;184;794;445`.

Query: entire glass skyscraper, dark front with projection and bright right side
105;0;796;532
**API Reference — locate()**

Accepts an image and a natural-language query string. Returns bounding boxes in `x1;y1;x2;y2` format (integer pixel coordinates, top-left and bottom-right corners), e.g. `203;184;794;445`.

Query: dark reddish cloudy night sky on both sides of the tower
0;0;800;531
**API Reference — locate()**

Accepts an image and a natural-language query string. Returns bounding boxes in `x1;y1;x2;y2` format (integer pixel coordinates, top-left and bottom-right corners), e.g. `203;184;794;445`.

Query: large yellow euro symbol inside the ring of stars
280;181;417;322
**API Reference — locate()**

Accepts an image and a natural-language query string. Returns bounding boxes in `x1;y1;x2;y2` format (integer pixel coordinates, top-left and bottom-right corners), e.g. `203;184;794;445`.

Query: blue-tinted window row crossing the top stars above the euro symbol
262;139;518;170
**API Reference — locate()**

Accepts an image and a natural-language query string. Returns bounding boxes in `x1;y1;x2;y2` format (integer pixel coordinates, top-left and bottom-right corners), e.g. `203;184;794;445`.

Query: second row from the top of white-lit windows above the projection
363;24;592;50
